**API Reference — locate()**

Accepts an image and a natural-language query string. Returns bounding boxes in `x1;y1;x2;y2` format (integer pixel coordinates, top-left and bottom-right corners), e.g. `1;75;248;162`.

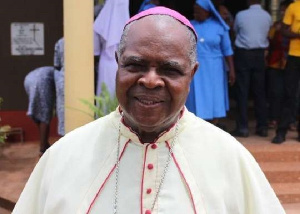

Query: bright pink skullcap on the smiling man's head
124;7;198;40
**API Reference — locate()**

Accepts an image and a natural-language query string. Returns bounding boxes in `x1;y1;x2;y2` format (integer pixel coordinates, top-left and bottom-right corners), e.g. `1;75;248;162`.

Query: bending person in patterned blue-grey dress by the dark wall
24;66;55;156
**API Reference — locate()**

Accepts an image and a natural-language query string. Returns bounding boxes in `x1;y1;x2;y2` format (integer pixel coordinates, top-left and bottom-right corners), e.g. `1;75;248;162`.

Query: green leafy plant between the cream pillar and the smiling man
76;83;119;118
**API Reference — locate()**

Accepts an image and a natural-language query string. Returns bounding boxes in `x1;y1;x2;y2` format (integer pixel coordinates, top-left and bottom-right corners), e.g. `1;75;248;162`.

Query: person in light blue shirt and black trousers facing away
231;0;272;137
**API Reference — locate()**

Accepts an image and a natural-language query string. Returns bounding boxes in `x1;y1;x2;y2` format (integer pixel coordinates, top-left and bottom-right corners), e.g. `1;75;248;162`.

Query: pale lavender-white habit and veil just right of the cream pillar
94;0;129;95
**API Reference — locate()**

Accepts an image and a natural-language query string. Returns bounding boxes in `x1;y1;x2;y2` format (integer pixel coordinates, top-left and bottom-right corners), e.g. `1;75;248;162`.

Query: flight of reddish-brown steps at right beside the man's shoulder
238;140;300;206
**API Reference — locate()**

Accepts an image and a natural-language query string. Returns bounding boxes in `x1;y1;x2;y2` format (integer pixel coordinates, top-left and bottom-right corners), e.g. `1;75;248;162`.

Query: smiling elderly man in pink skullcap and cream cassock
14;7;284;214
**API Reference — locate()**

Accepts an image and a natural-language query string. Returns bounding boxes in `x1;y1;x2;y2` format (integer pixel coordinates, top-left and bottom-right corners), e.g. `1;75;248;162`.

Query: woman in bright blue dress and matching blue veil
186;0;235;125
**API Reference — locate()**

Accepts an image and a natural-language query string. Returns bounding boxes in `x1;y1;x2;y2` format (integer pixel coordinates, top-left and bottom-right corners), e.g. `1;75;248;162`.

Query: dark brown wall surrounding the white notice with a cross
0;0;63;111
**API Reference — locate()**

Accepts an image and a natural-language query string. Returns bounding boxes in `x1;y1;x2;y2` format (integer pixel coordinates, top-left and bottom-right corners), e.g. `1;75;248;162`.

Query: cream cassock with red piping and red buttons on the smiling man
13;109;285;214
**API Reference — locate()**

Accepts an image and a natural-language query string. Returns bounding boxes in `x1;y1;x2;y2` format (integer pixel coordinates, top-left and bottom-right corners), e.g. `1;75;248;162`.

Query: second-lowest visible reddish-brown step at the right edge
271;182;300;204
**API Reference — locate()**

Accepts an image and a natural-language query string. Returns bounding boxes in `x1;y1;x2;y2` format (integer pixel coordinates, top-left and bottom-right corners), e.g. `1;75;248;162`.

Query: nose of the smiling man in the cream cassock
138;67;165;89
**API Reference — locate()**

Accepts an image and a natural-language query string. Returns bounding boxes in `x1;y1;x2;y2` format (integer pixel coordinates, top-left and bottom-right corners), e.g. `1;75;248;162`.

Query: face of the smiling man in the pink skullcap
116;17;197;137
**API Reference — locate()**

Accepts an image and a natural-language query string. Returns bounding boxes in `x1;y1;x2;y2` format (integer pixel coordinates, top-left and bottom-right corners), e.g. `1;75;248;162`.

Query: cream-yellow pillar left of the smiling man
64;0;94;133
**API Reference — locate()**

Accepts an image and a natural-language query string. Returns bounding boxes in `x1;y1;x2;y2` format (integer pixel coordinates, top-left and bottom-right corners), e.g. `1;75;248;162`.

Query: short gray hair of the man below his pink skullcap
117;15;197;66
